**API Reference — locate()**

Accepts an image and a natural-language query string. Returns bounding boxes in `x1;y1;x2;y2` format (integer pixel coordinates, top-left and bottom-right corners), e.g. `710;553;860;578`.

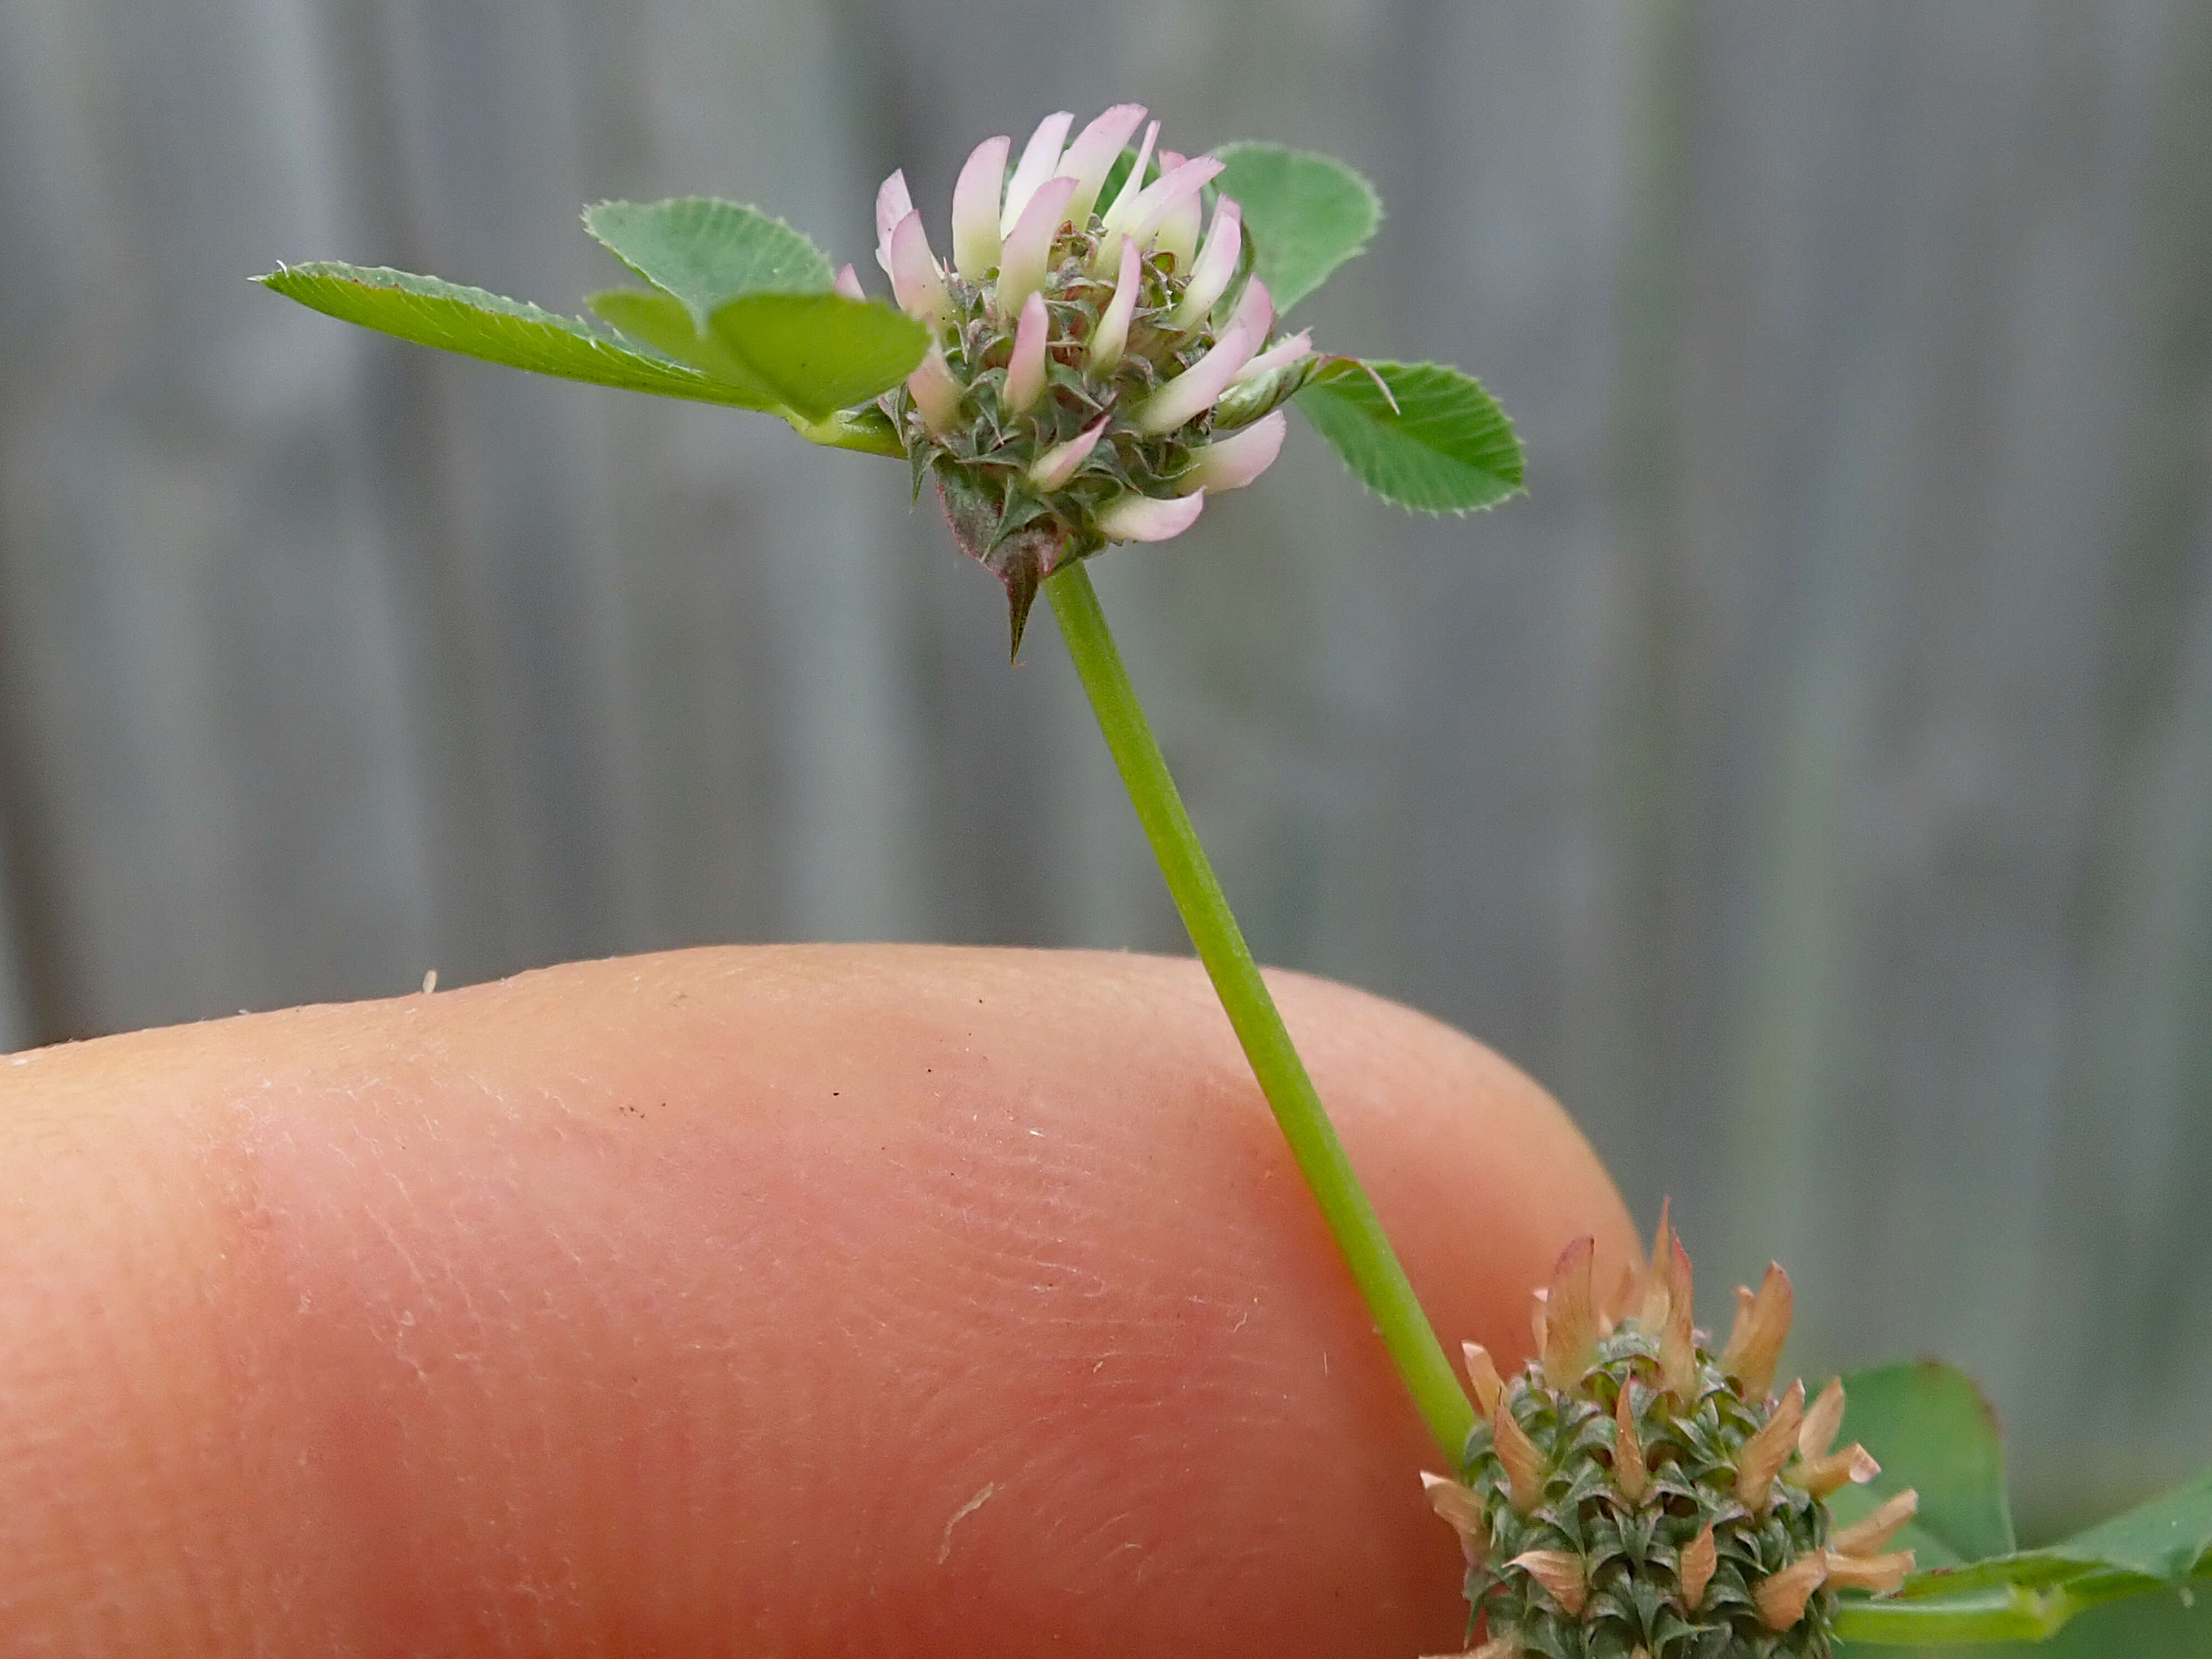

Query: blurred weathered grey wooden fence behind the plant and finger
0;0;2212;1628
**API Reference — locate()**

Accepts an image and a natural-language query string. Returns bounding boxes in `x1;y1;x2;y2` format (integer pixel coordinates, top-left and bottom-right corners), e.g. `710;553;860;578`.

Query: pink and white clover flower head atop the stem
858;104;1318;648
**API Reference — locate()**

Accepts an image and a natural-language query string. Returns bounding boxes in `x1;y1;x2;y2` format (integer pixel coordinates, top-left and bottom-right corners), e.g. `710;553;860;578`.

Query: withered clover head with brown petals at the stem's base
1422;1217;1916;1659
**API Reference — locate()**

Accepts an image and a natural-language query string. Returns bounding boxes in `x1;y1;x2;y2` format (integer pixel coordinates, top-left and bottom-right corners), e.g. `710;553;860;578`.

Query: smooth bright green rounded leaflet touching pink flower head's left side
708;294;929;420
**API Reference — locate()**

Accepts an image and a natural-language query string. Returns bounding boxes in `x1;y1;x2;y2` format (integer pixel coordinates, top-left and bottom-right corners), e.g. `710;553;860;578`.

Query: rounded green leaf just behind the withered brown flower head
1832;1360;2013;1568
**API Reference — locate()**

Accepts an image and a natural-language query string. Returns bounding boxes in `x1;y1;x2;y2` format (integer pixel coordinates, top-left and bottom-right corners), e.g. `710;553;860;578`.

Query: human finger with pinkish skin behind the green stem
0;947;1632;1659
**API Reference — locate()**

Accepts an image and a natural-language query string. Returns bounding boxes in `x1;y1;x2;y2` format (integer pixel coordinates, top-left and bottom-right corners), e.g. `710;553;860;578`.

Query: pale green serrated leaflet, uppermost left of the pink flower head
584;197;836;332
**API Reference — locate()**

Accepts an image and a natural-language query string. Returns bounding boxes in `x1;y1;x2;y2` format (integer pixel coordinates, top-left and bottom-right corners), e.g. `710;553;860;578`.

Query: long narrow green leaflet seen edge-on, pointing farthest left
257;263;761;407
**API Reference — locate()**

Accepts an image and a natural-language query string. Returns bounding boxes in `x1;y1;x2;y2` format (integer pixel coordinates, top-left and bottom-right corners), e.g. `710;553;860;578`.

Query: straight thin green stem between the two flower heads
1044;564;1475;1469
